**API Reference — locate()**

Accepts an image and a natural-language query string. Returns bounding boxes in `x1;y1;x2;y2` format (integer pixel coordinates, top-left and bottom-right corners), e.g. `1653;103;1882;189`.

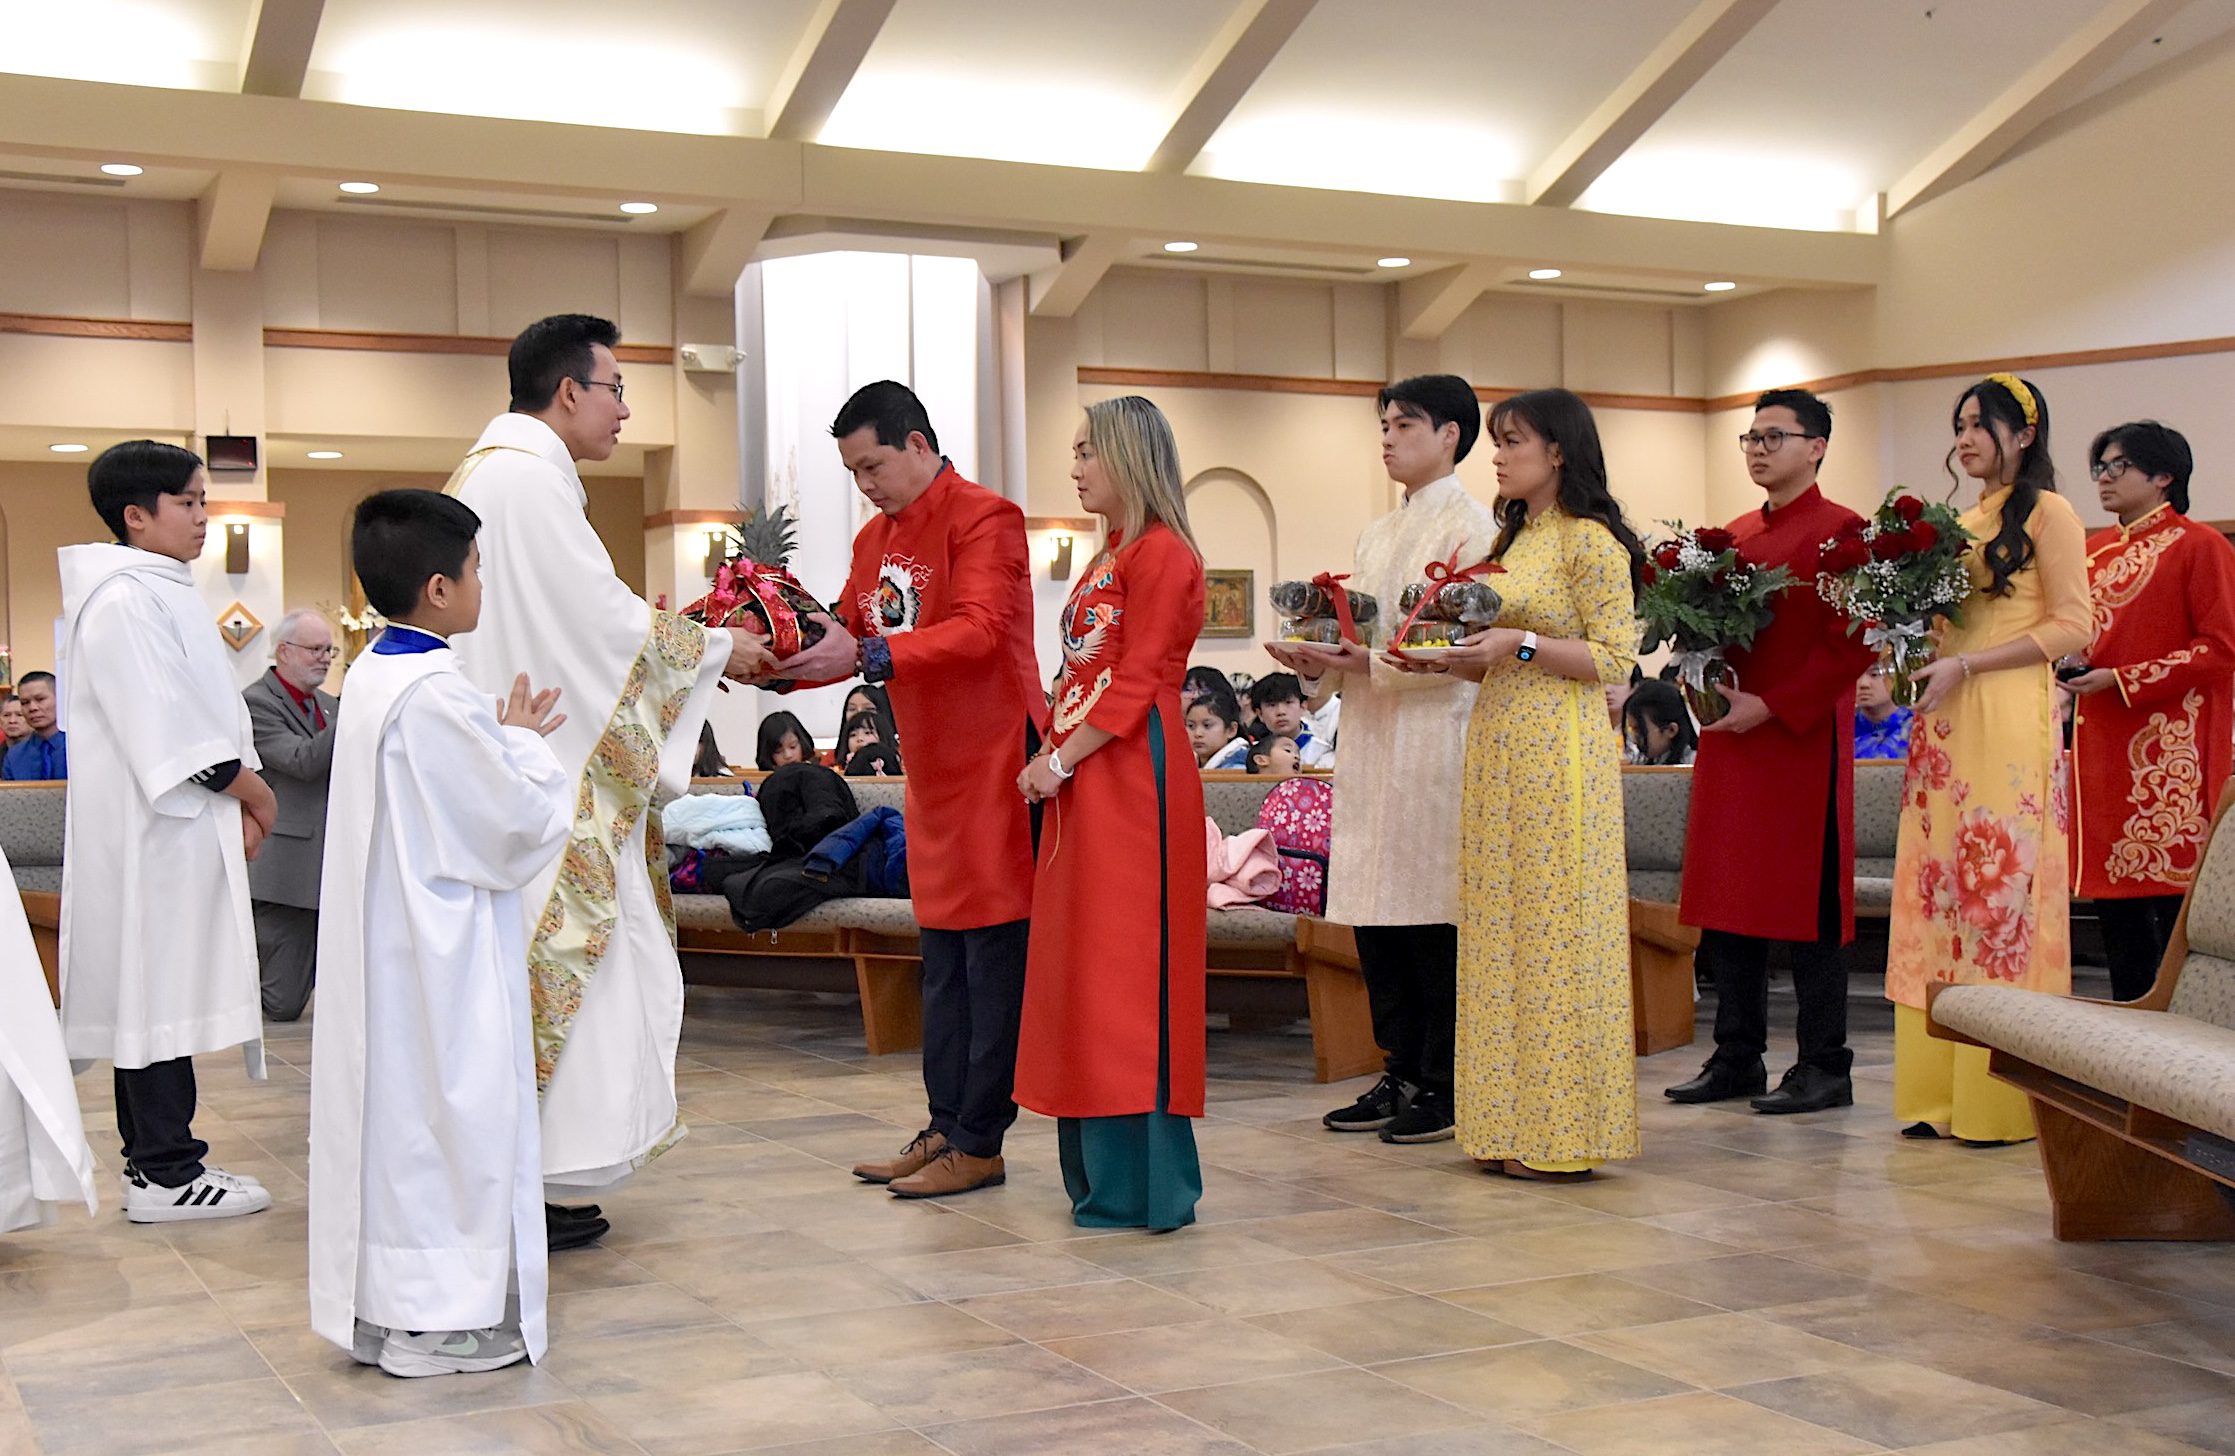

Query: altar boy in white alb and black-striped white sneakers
58;441;277;1223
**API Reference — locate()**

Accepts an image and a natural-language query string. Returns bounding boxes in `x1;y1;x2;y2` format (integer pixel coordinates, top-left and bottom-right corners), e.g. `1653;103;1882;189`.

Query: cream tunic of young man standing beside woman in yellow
1328;474;1497;926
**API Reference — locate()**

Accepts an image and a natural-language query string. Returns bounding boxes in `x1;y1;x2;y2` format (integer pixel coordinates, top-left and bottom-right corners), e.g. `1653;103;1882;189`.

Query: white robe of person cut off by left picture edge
0;840;101;1235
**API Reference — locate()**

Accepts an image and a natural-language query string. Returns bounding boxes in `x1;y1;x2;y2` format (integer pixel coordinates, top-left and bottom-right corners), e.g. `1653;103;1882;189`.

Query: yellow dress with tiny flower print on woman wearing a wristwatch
1455;505;1638;1172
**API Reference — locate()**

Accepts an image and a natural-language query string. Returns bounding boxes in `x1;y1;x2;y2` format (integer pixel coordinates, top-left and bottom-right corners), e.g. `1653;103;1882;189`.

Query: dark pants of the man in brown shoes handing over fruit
923;919;1033;1159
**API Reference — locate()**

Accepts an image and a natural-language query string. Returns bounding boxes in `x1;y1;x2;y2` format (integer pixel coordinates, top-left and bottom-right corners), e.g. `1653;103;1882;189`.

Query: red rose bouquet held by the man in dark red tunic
1638;521;1792;725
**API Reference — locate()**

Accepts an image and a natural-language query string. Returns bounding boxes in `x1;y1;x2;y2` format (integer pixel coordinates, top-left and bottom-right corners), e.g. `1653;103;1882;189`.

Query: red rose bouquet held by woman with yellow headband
1817;485;1971;707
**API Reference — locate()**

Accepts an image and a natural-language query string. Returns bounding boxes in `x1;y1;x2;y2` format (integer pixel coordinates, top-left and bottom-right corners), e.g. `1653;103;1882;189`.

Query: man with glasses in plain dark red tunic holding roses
1667;389;1871;1112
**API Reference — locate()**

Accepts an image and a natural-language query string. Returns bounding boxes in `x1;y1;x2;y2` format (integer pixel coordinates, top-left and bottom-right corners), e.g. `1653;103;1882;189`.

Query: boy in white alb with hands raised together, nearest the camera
311;490;572;1375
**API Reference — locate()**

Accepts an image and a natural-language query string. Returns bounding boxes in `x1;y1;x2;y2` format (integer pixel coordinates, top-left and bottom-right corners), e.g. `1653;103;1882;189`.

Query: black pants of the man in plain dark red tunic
1699;787;1855;1076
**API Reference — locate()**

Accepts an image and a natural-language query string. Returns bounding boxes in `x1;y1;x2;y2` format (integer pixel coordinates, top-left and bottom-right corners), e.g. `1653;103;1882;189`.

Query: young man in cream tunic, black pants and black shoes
1267;374;1497;1143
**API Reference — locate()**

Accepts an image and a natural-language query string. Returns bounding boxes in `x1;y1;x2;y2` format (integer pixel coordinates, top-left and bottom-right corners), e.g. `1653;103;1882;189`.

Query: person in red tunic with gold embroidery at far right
2065;420;2235;1002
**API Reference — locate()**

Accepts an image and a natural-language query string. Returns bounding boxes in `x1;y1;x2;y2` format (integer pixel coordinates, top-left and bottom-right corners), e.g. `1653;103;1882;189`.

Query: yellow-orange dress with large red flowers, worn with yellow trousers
1886;485;2092;1143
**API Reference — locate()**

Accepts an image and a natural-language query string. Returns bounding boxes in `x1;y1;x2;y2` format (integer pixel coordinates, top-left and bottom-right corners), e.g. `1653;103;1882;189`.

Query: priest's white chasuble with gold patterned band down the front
447;414;729;1192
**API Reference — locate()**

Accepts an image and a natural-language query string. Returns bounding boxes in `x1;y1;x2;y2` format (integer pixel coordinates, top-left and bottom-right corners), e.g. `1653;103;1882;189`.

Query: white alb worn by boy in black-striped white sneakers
56;546;264;1078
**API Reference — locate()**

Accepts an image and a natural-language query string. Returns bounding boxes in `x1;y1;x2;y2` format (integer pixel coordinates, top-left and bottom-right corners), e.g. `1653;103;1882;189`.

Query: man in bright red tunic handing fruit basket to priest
773;380;1048;1199
